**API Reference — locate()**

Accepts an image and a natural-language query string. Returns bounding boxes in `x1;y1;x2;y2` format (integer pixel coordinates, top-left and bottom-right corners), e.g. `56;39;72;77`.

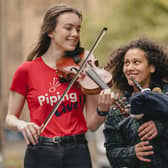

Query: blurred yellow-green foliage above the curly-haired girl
82;0;168;65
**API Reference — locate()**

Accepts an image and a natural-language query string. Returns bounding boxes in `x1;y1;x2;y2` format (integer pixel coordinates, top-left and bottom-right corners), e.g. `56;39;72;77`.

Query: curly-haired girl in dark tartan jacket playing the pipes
97;38;168;168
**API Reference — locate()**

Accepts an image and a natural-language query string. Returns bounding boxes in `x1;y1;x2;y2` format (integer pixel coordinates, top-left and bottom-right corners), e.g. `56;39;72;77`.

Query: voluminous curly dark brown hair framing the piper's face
105;37;168;92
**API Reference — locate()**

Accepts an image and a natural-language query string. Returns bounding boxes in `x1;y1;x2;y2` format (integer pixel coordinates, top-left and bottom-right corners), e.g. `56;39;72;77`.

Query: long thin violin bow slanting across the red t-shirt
40;27;107;133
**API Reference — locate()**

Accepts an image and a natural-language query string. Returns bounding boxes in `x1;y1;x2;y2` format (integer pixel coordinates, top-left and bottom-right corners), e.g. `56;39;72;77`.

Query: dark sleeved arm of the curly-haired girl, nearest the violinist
104;117;138;168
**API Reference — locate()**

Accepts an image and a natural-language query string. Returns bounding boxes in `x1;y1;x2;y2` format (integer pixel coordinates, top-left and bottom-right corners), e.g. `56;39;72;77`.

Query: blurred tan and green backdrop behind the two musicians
0;0;168;168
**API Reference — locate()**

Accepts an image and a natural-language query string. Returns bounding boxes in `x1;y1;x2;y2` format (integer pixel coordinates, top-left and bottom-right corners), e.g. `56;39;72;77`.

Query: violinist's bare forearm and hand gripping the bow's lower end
5;91;40;144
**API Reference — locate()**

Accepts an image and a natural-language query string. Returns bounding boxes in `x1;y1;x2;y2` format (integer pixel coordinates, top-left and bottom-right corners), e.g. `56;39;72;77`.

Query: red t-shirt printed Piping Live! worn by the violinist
10;57;87;137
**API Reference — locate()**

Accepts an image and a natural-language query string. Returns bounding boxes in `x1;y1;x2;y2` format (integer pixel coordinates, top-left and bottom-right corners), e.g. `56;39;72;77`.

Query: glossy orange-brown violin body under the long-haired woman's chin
56;52;112;95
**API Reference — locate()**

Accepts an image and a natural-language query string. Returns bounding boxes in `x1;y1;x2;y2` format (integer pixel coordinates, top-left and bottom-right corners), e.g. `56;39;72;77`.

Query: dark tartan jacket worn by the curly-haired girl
103;85;168;168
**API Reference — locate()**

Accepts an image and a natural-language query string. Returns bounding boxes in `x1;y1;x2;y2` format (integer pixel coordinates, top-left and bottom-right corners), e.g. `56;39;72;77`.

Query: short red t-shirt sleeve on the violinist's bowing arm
10;63;28;96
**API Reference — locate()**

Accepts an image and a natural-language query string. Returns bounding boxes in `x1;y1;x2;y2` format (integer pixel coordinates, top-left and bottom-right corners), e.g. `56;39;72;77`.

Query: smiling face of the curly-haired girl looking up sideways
123;48;155;90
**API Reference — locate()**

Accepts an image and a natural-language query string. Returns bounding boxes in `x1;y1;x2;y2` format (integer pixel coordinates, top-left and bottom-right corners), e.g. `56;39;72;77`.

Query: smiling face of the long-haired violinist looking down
48;12;81;52
